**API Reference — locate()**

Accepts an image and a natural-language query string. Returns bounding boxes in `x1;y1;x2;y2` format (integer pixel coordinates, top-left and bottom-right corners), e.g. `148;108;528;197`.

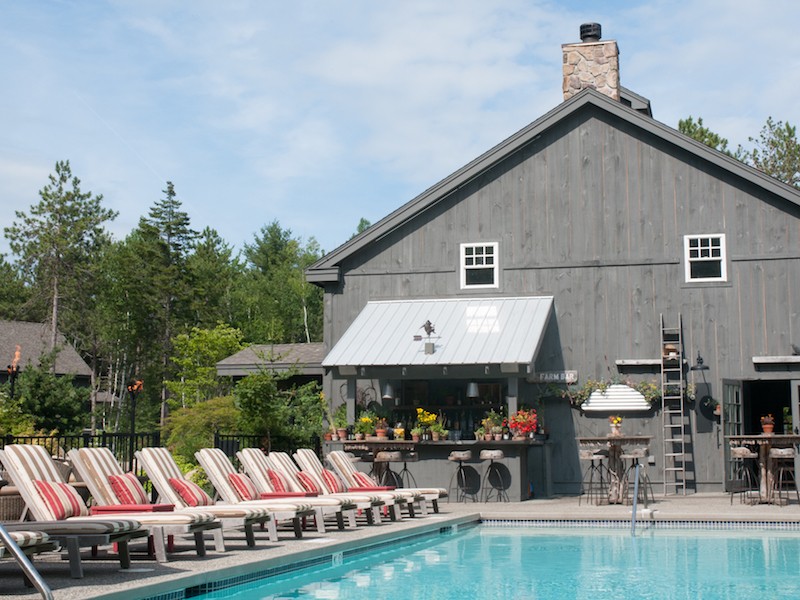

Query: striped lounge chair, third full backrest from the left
136;448;314;542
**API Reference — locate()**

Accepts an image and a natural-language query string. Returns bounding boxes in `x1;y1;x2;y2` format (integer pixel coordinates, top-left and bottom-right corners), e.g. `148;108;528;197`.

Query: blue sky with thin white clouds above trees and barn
0;0;800;252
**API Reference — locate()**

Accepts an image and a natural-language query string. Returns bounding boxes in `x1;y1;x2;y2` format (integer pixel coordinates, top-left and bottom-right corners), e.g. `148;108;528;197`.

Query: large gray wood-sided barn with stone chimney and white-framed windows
307;23;800;493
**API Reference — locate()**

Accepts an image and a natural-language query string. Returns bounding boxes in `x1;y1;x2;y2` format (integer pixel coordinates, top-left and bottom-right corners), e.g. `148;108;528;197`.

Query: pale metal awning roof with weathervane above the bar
322;296;553;367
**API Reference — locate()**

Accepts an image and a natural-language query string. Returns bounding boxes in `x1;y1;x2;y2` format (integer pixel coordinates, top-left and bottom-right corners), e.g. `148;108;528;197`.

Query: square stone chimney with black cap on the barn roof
561;23;619;101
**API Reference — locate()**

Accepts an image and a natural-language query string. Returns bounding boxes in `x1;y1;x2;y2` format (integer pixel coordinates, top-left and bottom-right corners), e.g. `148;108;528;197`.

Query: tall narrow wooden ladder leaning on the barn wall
661;314;690;496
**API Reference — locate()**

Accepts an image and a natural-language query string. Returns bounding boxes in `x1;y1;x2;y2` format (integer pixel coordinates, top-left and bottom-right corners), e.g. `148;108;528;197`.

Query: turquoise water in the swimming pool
192;527;800;600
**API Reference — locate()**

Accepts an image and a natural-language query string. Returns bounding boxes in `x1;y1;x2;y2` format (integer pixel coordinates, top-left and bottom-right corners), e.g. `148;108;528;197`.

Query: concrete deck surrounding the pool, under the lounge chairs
0;493;800;600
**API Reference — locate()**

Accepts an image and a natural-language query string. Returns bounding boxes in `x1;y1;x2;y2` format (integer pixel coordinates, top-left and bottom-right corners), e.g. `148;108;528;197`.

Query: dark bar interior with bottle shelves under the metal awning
387;380;505;441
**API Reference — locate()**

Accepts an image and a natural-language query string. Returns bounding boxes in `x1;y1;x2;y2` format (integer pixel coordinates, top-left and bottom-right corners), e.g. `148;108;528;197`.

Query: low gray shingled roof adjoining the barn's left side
217;342;325;377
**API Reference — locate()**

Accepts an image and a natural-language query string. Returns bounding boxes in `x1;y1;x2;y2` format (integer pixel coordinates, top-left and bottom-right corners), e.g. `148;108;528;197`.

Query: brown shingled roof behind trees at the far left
0;321;92;377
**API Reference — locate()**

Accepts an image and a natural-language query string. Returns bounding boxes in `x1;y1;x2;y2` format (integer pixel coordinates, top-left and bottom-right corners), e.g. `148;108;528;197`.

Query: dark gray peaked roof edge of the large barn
306;88;800;285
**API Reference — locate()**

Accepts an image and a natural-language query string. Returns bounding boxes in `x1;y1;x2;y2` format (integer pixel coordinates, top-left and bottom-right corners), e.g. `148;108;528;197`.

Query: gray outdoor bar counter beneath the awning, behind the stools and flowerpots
323;438;552;502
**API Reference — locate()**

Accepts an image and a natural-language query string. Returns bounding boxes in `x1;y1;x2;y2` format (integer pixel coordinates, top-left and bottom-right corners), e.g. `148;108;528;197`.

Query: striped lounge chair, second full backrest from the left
68;448;270;548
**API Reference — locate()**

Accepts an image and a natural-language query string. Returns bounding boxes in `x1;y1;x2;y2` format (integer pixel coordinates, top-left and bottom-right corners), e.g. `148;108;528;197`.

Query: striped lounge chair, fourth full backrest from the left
194;448;355;533
